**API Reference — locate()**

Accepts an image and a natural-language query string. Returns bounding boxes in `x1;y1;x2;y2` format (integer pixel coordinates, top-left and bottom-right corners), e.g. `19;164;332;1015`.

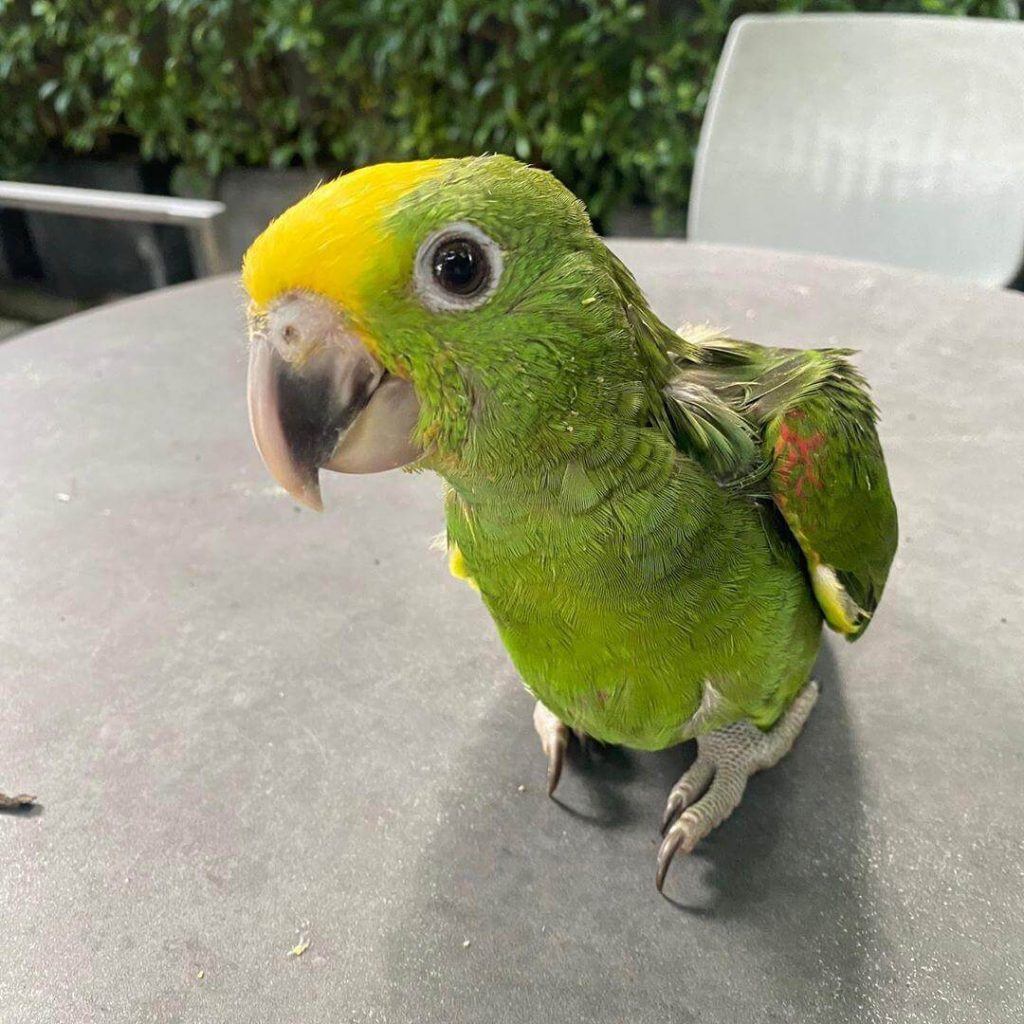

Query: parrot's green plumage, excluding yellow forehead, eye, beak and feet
356;157;895;749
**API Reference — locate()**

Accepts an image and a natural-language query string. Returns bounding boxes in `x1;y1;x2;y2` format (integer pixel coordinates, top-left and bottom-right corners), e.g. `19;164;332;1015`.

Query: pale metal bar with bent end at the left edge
0;181;226;276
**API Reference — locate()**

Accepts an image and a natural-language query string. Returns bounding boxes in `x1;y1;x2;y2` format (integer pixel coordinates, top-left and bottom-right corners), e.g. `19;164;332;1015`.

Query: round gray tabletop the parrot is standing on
0;242;1024;1024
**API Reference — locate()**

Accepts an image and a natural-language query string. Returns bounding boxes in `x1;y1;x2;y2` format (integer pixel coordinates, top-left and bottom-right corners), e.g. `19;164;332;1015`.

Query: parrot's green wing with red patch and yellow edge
667;329;897;640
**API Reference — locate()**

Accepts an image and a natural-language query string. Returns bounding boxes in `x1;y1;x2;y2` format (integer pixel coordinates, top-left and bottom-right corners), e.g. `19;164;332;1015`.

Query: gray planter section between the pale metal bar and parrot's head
172;167;323;267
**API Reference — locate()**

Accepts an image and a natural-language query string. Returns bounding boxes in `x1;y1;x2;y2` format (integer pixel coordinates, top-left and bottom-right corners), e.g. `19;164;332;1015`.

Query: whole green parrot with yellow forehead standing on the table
243;155;897;892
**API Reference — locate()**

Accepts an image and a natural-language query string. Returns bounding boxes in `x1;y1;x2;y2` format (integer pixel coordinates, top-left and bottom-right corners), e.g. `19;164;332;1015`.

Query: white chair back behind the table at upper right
688;14;1024;286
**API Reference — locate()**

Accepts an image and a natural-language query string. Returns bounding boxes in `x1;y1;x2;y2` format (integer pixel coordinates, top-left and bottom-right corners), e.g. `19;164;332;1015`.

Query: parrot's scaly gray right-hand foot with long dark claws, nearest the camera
655;680;818;892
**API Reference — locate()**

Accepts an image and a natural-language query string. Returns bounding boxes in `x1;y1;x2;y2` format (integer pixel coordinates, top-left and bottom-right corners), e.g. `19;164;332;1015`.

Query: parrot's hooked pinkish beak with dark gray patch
249;292;423;511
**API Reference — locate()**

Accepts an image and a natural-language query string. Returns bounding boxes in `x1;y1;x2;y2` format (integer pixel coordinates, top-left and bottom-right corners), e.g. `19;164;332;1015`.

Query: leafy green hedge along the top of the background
0;0;1019;228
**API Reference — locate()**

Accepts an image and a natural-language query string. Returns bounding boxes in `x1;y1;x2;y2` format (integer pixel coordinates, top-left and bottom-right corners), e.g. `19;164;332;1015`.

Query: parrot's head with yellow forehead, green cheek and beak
243;156;622;505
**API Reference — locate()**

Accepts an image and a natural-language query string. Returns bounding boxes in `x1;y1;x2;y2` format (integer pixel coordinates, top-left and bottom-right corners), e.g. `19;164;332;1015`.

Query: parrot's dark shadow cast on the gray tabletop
386;647;879;1024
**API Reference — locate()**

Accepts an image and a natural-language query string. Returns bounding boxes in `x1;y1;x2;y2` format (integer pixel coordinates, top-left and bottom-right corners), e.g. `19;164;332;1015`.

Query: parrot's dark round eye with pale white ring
416;223;502;311
